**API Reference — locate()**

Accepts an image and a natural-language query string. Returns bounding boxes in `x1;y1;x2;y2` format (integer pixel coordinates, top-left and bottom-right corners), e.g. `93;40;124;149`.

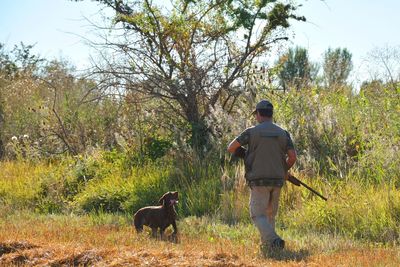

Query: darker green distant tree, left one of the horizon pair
278;46;318;91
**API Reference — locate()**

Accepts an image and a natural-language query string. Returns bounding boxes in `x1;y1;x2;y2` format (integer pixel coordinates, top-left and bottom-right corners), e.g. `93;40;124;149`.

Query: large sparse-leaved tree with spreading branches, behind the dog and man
72;0;305;152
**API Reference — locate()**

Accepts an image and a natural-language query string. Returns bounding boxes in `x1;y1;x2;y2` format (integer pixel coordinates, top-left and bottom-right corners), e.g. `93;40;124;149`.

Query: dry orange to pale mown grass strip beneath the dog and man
0;214;400;266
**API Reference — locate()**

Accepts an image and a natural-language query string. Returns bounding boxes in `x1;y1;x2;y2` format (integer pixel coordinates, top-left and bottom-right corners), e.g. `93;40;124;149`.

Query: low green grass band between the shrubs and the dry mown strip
0;157;400;245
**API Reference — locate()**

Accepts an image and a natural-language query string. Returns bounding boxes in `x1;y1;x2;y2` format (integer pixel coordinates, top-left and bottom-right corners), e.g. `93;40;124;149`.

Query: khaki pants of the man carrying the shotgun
250;186;281;245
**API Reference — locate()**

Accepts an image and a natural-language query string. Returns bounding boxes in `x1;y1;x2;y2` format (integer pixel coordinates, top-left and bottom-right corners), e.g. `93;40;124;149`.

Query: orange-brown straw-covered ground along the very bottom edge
0;229;400;266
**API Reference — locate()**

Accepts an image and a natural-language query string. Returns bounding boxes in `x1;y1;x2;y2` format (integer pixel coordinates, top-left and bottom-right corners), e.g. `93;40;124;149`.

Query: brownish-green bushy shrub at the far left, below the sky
0;50;122;157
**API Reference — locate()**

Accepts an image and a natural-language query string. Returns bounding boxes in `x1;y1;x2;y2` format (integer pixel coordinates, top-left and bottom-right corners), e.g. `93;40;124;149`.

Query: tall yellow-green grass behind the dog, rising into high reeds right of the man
0;85;400;244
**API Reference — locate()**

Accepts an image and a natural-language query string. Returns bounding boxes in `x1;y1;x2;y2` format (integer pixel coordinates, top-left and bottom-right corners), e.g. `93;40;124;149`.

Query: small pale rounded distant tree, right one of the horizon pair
323;48;353;87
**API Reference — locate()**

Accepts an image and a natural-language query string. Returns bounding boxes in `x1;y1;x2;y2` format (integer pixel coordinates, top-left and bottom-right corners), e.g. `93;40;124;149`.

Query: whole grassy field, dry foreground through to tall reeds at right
0;85;400;266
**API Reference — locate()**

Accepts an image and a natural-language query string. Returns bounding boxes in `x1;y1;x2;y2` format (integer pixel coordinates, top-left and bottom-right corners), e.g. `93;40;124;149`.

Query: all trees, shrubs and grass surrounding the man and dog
0;1;400;266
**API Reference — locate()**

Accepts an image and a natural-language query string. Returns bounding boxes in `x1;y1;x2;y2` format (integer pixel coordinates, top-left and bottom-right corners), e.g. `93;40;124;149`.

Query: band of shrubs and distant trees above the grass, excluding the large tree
0;44;400;184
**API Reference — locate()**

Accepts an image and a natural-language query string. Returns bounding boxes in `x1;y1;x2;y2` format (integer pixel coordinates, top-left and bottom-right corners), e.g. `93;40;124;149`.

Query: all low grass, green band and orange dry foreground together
0;154;400;266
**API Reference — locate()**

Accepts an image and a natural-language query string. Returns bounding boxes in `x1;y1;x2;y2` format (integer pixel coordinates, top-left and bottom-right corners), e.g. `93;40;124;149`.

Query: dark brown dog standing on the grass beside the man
133;192;178;239
